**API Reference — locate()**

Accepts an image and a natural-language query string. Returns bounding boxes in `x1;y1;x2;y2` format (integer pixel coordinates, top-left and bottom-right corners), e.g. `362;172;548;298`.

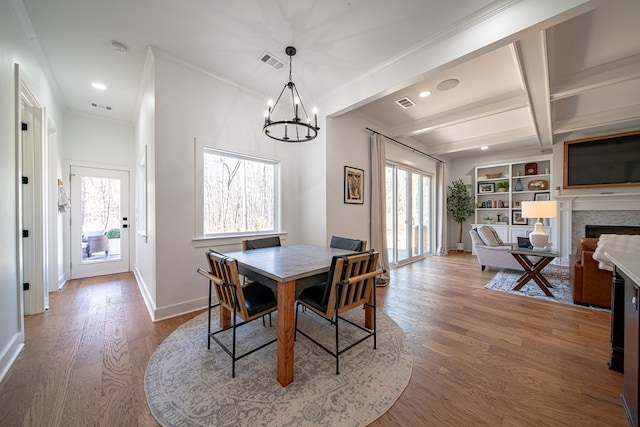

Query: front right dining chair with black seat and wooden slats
294;251;384;375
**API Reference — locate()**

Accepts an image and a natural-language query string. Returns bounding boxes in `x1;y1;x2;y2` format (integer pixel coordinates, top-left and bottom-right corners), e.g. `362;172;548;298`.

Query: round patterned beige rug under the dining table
144;309;413;427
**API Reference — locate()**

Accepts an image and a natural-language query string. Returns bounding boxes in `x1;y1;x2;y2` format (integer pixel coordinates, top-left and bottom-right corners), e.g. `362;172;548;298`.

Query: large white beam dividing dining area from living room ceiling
319;0;601;117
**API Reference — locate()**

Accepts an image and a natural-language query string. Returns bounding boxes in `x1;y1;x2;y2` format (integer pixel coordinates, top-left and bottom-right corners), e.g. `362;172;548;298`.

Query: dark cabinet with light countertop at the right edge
605;251;640;426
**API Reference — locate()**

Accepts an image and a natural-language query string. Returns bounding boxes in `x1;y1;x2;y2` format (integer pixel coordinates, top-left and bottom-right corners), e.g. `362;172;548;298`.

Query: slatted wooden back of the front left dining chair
207;250;249;320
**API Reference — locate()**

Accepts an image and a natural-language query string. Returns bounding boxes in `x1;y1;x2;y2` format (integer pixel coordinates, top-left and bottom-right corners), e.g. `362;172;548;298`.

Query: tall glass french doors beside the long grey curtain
385;164;433;266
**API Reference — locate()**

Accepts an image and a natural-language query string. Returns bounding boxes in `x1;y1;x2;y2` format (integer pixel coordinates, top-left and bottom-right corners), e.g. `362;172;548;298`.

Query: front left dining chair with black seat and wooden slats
198;249;278;378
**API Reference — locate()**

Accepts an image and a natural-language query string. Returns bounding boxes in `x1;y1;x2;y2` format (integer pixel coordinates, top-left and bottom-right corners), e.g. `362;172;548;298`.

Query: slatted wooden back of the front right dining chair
326;251;383;317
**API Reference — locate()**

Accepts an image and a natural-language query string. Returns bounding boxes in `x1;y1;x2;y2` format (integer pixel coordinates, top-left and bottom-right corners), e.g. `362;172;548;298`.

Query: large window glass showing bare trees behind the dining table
203;149;276;234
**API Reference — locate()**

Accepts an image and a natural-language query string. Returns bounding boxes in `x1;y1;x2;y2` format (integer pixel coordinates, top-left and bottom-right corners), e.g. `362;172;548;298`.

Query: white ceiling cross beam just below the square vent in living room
389;91;528;138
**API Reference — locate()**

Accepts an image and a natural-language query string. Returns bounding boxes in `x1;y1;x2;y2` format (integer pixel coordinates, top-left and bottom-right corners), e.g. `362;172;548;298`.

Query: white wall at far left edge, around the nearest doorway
0;1;62;379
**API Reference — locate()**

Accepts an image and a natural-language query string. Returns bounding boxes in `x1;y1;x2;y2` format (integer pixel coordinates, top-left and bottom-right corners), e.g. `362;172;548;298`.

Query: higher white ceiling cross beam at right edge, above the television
550;54;640;101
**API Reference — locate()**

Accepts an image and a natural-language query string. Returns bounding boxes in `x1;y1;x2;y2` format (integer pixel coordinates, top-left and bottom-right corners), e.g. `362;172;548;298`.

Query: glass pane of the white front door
79;176;121;262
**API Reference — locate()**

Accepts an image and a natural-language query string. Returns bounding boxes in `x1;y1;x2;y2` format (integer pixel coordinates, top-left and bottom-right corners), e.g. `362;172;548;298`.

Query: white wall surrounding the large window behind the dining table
144;52;306;319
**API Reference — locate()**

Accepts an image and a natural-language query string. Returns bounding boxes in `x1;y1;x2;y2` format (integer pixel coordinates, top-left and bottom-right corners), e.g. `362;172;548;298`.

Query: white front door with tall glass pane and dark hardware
71;166;131;279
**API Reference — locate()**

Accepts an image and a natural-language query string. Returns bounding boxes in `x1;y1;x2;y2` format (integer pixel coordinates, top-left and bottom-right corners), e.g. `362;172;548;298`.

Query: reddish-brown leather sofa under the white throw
571;237;613;308
